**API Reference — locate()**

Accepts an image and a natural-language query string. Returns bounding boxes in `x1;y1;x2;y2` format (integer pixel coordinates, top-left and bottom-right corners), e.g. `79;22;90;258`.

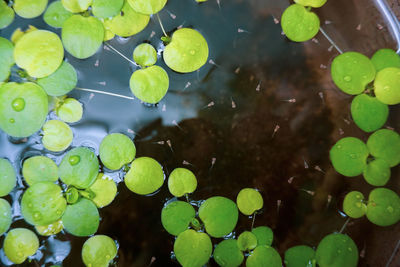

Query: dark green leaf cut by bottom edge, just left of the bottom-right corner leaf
284;246;315;267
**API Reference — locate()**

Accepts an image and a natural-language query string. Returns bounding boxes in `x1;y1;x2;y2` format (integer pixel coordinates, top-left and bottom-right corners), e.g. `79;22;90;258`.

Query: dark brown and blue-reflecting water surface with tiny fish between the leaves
0;0;400;266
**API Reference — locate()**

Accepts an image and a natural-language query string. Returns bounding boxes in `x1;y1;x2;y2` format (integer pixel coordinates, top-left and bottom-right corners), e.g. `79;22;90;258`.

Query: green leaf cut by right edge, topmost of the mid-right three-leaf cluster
367;129;400;167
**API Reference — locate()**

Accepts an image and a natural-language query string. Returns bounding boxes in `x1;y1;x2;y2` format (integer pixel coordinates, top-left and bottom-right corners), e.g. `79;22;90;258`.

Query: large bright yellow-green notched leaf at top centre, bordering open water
163;28;209;73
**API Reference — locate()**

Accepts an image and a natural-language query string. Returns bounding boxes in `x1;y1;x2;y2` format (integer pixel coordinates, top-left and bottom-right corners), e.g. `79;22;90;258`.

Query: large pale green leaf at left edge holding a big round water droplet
0;83;48;137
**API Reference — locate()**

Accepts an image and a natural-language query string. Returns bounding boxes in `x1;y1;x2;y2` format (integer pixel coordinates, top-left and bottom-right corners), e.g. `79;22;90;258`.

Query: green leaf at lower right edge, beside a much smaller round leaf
367;188;400;226
